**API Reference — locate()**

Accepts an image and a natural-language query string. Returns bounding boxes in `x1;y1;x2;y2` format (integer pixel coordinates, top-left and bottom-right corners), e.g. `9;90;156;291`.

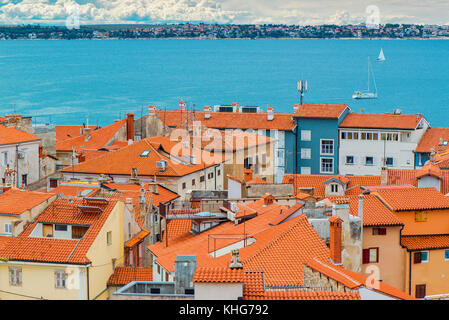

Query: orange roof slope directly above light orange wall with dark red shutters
348;194;404;227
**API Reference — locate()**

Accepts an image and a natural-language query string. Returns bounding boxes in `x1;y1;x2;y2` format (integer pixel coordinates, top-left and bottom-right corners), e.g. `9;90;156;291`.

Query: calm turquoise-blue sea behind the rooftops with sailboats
0;40;449;126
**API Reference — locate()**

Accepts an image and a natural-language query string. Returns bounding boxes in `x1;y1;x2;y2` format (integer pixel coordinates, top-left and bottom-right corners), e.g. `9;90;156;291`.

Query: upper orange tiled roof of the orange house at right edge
376;188;449;211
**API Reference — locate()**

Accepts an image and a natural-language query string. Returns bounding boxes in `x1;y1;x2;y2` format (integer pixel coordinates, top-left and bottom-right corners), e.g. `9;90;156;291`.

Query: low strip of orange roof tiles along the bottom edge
244;290;361;300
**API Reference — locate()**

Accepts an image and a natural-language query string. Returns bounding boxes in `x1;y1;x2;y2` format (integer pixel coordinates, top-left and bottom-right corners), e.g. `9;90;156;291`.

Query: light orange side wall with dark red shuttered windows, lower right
362;226;406;291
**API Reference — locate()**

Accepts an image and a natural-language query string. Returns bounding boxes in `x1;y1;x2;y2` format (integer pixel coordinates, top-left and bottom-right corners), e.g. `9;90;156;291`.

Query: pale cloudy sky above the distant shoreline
0;0;449;25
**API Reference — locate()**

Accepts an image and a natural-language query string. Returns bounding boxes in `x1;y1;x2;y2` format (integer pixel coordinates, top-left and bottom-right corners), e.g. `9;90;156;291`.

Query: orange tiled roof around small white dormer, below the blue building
282;174;381;198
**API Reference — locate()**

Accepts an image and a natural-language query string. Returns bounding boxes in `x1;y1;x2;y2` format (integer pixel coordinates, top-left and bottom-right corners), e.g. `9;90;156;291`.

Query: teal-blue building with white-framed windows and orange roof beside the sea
292;104;350;174
